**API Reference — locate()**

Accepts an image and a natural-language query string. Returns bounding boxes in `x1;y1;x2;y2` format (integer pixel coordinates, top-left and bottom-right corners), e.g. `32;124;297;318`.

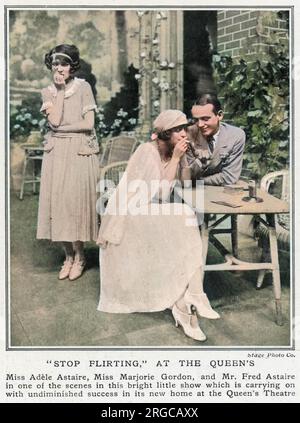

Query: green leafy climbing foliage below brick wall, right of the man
214;43;289;178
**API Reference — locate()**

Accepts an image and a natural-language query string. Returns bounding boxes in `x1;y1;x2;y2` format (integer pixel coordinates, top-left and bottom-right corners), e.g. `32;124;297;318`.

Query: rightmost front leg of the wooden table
266;214;283;326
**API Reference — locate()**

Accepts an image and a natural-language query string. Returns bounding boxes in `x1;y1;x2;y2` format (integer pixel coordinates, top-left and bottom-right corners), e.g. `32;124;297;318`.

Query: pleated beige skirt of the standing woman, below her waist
37;134;99;242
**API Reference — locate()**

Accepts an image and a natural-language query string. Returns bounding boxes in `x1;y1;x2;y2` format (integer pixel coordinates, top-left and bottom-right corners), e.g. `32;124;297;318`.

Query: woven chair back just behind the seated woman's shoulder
100;134;139;167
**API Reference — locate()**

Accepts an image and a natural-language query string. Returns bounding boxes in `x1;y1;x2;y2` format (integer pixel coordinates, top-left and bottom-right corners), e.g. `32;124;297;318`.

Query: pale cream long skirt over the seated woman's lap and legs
98;203;202;313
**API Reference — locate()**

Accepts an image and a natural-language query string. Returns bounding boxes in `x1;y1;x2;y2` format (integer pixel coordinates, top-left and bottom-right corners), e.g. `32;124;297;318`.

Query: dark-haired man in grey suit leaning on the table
186;94;245;185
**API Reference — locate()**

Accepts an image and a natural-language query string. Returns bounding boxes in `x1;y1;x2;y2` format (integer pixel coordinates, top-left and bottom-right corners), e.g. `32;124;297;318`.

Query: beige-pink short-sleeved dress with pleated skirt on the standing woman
37;78;99;242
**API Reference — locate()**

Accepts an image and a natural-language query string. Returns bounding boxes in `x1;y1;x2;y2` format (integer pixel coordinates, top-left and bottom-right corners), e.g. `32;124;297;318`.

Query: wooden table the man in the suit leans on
192;183;289;325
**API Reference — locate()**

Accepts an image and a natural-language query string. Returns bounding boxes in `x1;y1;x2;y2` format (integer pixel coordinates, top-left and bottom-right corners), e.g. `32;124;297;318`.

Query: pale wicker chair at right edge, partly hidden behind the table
256;169;290;289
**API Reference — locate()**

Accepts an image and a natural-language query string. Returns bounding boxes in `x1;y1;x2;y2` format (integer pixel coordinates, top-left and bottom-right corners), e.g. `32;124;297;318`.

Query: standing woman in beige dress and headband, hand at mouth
37;44;99;280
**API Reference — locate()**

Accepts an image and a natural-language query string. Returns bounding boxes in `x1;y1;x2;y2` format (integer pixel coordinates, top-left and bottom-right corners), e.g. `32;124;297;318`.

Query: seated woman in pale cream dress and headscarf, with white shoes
97;110;220;341
